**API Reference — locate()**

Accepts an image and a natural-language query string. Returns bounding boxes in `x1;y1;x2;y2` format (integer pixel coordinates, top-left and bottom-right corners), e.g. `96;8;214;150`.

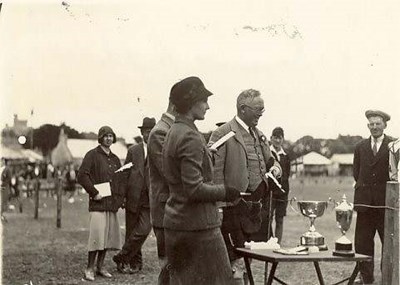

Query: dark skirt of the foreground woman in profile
165;228;233;285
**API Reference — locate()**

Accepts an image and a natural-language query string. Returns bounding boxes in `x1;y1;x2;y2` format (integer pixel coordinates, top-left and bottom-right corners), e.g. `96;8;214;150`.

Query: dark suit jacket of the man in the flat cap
353;135;392;211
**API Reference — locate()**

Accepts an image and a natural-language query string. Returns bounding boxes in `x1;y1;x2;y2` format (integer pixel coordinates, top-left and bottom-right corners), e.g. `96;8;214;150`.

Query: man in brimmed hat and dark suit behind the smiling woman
113;117;156;273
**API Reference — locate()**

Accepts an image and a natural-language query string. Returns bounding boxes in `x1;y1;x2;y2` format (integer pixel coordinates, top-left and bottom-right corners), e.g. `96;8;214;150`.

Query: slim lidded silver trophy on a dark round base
333;195;354;256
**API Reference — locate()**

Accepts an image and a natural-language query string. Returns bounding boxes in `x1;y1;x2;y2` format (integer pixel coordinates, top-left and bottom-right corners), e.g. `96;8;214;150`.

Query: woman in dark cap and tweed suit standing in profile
163;77;240;285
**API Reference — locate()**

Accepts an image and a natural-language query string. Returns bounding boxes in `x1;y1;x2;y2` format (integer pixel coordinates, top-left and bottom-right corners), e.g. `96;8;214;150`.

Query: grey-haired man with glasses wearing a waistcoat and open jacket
209;89;281;284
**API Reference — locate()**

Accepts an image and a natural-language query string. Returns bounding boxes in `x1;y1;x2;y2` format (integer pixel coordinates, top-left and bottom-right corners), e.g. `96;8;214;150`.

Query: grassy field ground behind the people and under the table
1;178;381;285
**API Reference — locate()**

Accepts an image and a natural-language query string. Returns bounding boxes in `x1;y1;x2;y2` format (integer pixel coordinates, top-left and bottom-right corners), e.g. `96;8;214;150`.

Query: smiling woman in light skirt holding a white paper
78;126;121;281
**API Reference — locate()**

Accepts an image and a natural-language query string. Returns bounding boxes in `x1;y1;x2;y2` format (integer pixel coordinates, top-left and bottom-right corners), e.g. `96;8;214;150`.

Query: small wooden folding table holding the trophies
236;248;372;285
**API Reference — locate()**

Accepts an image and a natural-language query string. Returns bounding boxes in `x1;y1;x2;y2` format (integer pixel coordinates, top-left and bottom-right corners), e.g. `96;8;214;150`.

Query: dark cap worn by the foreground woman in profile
169;76;212;113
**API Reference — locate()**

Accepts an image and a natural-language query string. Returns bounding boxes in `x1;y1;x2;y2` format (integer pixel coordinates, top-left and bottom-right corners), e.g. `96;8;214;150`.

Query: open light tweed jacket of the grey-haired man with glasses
209;118;281;195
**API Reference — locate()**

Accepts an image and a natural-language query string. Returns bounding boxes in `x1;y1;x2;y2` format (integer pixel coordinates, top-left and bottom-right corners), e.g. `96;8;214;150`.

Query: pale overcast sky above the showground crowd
0;0;400;141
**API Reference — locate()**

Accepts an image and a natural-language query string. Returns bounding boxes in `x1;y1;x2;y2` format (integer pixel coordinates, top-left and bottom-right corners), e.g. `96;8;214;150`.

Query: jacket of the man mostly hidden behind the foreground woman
148;114;174;228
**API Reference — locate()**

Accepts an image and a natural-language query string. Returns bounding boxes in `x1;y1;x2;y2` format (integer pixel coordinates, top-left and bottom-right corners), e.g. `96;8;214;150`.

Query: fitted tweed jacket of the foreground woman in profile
163;117;225;231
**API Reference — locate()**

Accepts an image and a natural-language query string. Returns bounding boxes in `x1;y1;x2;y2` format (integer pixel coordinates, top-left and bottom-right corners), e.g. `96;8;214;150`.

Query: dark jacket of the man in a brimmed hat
125;143;149;212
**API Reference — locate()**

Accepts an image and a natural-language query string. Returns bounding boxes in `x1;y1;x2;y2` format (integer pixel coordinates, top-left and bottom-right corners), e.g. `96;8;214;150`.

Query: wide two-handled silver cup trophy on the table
297;201;328;250
